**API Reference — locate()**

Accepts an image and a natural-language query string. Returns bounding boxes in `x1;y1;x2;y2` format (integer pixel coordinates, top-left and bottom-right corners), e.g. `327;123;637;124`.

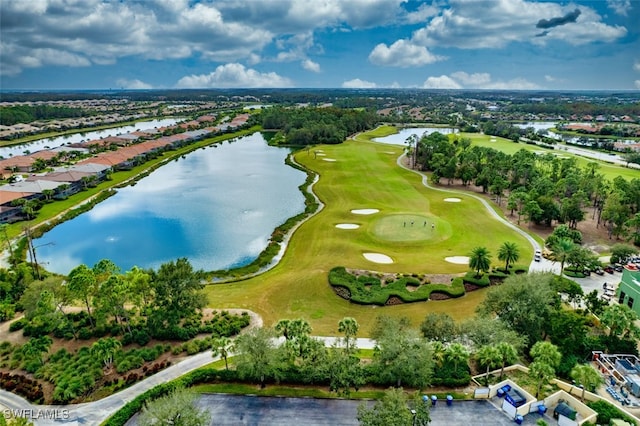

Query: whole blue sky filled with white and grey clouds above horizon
0;0;640;90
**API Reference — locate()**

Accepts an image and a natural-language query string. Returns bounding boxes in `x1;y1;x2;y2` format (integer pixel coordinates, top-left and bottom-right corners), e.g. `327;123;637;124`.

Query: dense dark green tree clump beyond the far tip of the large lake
261;107;379;146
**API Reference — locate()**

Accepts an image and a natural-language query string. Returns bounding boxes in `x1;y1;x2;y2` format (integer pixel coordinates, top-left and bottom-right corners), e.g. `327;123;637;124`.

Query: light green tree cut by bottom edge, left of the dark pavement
138;388;211;426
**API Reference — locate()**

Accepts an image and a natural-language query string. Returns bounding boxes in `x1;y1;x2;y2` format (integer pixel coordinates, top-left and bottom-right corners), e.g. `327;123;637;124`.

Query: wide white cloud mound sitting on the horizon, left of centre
176;63;293;88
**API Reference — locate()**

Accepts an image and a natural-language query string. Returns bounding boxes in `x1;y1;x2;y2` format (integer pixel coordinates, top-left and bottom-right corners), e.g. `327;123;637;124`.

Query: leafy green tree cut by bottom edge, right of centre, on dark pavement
358;388;431;426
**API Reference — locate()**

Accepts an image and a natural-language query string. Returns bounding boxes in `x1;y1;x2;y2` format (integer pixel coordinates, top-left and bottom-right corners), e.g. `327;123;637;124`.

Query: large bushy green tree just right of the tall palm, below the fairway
371;316;433;388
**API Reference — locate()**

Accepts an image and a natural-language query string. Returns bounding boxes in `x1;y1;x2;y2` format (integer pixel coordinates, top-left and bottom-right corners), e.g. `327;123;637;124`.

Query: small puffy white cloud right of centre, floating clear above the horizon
369;40;443;68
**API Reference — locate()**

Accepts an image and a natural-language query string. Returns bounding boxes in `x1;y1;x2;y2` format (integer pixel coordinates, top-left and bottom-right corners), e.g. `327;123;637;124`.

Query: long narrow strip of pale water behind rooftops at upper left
0;118;182;158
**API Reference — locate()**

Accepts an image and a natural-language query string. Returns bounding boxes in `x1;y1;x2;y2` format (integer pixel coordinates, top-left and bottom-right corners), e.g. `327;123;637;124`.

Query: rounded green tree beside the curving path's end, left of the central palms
235;328;280;388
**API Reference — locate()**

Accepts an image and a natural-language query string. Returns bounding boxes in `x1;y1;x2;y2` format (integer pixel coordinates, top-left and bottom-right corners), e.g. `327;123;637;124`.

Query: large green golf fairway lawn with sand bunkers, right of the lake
207;135;533;336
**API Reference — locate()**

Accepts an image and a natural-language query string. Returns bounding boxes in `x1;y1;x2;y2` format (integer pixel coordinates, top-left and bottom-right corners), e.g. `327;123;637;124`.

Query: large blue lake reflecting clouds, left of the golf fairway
34;133;306;274
